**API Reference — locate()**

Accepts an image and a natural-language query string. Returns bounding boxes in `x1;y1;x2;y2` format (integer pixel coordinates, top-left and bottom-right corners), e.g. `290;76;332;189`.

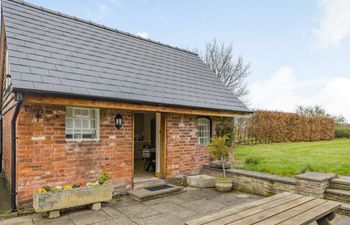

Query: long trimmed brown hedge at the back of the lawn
248;111;334;143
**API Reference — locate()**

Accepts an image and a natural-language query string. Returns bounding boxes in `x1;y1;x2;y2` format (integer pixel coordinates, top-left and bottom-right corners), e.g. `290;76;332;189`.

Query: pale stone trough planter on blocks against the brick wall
33;184;113;218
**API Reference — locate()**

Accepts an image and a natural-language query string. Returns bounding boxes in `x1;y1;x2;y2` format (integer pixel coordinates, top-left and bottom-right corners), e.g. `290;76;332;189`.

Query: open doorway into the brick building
134;112;160;181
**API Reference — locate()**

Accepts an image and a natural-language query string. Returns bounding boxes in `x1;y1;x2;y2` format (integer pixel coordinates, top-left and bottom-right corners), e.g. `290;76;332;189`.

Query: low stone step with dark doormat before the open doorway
128;184;185;201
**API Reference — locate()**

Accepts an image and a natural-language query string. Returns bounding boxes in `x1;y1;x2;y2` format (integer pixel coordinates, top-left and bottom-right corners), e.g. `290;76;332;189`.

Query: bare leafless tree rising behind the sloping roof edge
201;39;250;97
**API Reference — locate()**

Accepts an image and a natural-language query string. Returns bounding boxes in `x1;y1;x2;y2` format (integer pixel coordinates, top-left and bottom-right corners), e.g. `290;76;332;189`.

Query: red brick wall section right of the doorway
166;114;215;178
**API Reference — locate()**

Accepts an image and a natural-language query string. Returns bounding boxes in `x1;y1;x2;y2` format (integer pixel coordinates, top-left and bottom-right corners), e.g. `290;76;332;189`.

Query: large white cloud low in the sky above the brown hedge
249;66;350;122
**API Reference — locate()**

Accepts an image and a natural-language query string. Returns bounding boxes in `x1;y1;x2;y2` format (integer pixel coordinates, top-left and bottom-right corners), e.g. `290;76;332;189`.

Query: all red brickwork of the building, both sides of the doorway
3;102;230;208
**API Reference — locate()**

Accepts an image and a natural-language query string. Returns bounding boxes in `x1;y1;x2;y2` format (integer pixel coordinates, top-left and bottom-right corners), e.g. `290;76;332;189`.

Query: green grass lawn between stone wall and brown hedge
235;139;350;176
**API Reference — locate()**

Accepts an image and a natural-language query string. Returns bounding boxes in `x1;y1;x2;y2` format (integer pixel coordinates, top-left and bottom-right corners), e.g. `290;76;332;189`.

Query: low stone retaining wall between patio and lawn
202;166;335;198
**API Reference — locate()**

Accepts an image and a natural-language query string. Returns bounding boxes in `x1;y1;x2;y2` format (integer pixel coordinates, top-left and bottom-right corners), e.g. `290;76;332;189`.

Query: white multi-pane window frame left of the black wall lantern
65;106;100;141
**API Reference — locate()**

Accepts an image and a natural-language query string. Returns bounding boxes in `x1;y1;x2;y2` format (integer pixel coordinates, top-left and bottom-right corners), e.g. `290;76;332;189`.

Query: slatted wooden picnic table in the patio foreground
185;192;340;225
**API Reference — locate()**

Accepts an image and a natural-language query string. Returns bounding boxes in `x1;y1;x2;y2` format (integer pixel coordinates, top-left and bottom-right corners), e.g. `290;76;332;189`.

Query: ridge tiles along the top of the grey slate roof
1;0;198;56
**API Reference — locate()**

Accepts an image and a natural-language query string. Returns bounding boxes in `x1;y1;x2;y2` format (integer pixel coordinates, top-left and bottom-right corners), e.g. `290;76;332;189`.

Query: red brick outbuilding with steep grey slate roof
0;0;249;210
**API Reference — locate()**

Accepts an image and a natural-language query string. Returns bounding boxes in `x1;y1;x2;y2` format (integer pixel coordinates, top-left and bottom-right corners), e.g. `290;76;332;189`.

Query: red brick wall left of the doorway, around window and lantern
17;104;133;205
